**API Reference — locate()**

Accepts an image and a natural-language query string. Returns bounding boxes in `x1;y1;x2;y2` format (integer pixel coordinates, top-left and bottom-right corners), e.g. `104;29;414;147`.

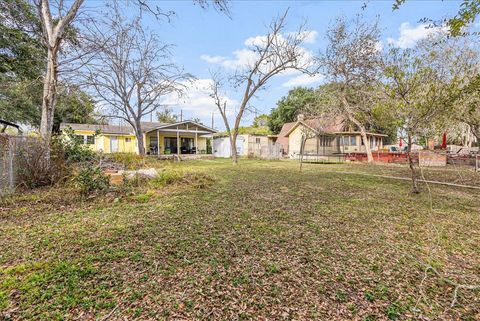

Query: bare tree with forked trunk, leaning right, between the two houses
211;10;311;165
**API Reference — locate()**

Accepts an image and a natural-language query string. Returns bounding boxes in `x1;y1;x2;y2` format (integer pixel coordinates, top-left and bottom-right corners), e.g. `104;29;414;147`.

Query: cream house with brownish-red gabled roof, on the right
277;117;388;158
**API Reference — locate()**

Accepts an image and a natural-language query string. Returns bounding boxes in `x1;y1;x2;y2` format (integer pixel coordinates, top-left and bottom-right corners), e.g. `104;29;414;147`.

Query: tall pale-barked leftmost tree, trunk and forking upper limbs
34;0;84;145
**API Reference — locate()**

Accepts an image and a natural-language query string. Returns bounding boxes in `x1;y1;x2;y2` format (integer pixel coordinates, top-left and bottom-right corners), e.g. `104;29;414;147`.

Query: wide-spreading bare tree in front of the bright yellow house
82;6;192;155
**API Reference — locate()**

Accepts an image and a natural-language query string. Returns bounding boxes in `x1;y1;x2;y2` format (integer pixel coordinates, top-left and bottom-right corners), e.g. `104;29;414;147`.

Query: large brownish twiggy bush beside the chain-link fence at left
16;138;70;188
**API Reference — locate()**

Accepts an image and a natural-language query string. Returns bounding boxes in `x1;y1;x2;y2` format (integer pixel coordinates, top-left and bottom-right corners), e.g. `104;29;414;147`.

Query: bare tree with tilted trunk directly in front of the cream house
318;16;382;162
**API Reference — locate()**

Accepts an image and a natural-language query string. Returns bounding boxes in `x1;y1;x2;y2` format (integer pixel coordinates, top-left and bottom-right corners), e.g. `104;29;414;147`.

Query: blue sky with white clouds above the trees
106;0;460;130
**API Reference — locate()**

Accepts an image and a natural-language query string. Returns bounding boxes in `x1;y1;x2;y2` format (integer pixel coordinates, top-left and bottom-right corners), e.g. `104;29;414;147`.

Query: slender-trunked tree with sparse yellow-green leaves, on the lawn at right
384;38;475;193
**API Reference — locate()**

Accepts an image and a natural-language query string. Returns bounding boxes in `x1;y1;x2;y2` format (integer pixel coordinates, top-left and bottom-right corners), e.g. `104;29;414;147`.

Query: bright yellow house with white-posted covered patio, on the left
60;121;216;155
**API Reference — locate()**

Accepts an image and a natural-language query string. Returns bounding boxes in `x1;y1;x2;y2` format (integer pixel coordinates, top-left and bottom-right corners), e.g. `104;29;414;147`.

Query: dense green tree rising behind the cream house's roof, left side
268;87;316;134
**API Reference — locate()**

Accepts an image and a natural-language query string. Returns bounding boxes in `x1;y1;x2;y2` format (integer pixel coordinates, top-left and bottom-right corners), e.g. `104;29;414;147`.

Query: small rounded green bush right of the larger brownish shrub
73;166;110;196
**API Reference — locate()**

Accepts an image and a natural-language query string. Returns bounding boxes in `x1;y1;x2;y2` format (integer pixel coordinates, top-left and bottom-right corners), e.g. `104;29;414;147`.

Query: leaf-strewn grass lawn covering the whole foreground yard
0;160;480;320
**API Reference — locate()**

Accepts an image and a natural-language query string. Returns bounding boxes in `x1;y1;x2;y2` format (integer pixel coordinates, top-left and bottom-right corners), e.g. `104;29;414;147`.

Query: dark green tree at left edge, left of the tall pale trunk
0;0;46;125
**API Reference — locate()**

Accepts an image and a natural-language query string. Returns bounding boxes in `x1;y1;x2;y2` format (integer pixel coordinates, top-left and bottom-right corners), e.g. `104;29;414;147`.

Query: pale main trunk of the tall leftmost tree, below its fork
40;46;58;145
